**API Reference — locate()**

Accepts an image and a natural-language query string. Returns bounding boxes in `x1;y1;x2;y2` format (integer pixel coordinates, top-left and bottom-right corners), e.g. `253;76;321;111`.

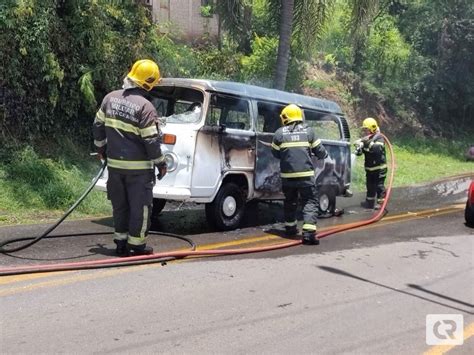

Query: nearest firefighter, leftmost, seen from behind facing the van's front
93;59;167;256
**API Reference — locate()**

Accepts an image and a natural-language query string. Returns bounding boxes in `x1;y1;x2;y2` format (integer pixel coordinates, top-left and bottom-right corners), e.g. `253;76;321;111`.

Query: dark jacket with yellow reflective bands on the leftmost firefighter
93;88;164;174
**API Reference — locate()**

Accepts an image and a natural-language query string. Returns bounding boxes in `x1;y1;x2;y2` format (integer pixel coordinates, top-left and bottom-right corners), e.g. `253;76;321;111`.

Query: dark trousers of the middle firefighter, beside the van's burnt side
282;184;319;234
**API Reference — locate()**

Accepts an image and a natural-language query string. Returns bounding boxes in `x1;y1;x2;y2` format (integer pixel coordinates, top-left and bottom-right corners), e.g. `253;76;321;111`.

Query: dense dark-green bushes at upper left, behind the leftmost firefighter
0;0;174;146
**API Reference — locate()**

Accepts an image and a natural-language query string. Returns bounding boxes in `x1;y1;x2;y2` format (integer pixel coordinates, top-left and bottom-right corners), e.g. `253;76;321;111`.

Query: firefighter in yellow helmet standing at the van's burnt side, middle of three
272;104;328;245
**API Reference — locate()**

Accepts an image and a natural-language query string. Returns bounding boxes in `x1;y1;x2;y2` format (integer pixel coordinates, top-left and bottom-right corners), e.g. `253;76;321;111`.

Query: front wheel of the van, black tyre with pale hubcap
206;183;245;230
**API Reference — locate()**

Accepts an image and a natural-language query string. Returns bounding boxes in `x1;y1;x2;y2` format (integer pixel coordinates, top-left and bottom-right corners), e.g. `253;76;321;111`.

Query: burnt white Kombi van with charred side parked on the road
97;78;351;230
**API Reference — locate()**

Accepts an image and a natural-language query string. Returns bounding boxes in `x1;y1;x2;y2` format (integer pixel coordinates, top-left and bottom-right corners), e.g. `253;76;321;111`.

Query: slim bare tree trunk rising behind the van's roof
274;0;295;90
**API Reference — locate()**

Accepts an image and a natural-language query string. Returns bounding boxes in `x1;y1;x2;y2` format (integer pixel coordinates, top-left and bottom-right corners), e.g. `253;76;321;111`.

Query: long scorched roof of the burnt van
159;78;342;114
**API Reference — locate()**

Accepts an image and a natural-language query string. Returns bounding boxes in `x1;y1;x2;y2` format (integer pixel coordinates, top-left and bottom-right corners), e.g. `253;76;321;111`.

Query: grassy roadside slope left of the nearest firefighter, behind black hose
0;142;111;225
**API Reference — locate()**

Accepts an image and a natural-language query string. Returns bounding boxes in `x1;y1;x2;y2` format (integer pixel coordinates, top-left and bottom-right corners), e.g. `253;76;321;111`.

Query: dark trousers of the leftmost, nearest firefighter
107;170;155;247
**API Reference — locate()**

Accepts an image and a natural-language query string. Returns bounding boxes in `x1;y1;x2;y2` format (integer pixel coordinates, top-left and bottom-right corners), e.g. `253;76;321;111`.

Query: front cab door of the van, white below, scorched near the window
192;93;255;200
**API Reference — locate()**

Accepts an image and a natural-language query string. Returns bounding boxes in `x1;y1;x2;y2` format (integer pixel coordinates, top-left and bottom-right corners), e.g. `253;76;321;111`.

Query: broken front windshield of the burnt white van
151;86;204;124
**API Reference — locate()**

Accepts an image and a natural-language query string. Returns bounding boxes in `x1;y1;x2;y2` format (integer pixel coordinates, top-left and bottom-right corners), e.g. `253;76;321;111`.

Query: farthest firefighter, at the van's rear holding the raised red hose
354;117;387;210
